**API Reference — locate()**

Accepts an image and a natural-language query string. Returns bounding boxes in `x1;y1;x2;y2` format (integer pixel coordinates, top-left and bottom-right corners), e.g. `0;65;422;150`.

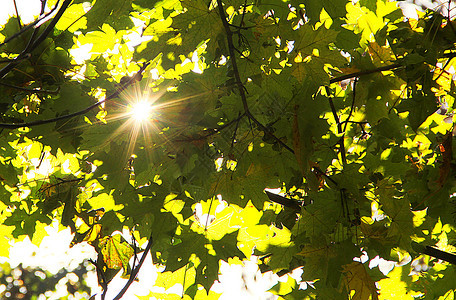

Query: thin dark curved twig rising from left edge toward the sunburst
0;62;149;129
